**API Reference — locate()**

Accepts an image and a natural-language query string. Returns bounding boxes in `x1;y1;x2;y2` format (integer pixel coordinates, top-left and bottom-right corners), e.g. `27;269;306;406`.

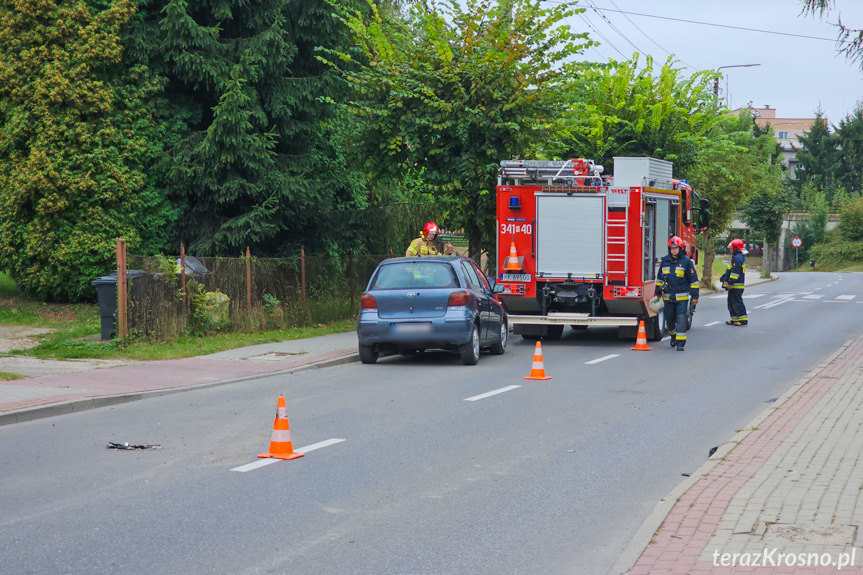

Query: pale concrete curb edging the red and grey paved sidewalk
609;339;854;575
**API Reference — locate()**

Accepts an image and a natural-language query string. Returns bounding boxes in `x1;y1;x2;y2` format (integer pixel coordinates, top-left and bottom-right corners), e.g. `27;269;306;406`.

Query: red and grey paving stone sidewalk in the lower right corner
615;340;863;575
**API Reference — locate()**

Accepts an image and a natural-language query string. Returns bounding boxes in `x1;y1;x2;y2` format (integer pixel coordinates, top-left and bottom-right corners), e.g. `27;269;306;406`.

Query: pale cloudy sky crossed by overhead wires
571;0;863;123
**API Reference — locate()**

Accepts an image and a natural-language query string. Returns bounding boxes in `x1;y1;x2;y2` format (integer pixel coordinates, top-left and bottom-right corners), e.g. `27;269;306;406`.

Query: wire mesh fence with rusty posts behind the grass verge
121;252;392;341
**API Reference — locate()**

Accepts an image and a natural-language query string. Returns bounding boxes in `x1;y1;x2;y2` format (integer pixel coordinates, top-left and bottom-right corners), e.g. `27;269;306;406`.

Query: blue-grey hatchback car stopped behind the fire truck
357;256;508;365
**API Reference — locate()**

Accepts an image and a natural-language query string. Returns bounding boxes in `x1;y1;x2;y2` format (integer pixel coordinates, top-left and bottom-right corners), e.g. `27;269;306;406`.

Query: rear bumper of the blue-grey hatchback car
357;310;474;349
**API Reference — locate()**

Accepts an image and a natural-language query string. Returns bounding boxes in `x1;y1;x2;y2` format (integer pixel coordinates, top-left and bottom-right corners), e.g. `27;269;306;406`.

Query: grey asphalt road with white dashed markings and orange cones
0;273;863;575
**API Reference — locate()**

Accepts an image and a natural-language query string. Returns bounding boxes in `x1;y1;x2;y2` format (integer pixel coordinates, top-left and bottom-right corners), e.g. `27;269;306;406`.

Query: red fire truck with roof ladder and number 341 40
497;158;710;341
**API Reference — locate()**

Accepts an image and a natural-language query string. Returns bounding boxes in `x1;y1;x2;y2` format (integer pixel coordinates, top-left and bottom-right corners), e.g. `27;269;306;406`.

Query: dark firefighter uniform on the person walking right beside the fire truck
656;253;699;350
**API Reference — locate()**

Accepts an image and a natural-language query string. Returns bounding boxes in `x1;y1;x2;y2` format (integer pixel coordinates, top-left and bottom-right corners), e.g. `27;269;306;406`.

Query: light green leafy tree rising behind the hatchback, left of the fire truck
328;0;589;260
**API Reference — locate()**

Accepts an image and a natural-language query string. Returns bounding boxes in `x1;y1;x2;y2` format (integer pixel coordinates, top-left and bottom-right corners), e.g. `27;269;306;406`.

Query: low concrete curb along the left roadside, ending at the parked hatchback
0;353;360;426
